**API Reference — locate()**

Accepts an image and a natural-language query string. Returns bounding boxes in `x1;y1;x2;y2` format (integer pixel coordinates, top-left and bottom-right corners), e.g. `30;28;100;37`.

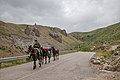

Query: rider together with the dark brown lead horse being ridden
27;40;41;69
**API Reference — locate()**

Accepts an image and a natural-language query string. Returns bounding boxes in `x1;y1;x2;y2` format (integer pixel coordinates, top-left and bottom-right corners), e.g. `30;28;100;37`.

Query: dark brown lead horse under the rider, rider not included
27;45;41;70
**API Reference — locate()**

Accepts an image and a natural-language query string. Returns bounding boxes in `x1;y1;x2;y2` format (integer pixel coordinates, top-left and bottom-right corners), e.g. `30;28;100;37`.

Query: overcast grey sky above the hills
0;0;120;32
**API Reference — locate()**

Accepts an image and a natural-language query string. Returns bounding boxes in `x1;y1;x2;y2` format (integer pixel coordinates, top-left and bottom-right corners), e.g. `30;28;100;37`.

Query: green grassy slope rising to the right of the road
70;23;120;51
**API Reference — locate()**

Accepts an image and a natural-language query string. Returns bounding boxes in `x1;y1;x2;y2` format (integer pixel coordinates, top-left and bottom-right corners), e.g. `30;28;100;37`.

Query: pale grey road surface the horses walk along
0;52;102;80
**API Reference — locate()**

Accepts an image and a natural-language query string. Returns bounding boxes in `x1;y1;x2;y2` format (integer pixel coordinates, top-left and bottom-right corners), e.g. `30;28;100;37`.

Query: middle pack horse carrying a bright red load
40;47;51;64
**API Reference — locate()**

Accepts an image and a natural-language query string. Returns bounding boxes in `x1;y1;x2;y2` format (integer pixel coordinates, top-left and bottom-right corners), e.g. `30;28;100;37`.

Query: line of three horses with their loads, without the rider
27;45;59;70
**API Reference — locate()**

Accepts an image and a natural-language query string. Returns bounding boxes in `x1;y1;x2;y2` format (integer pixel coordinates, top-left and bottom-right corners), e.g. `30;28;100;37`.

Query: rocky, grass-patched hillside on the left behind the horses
0;21;79;57
